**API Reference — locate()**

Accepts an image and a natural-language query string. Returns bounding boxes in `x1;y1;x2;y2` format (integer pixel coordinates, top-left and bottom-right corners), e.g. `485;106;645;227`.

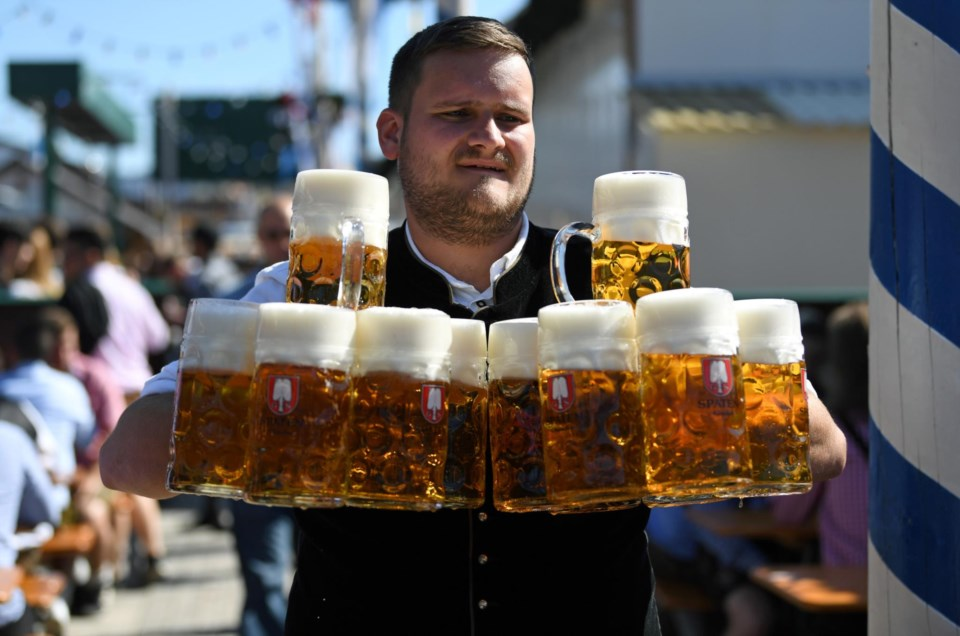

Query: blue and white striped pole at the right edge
869;0;960;636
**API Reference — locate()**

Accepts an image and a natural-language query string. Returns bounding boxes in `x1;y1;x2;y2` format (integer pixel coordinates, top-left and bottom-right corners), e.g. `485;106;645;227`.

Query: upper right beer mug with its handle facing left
550;171;690;304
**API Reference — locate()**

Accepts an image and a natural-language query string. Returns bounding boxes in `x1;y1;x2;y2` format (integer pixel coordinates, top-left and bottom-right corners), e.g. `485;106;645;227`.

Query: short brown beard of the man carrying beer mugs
397;147;533;245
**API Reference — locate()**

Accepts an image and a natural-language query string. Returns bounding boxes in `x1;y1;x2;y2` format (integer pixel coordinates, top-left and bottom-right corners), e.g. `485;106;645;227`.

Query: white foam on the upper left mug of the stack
291;169;390;249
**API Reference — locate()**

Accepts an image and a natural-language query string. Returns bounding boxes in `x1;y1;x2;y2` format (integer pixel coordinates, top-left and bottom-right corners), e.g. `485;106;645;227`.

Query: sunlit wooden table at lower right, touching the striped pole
750;564;867;612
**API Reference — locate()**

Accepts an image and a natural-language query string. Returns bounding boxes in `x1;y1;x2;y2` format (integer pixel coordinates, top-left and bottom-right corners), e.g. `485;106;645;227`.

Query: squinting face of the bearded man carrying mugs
388;50;534;244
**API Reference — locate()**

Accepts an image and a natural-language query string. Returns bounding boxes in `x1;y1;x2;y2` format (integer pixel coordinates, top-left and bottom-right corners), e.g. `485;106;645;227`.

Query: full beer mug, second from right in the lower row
636;288;750;505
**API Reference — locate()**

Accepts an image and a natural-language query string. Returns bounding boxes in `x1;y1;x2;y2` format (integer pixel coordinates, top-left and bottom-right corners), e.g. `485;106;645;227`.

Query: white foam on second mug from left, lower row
256;302;357;370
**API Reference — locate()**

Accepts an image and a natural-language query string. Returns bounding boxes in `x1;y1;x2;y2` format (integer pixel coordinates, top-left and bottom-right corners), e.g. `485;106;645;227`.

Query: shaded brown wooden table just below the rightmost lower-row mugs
686;506;817;547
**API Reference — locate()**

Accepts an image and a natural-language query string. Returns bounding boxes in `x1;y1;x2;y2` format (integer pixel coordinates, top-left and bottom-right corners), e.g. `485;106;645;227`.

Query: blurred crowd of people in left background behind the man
0;197;293;636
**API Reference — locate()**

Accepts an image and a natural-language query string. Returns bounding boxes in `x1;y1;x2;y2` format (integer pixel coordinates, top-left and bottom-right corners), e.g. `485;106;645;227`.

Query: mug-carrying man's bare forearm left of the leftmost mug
100;393;175;499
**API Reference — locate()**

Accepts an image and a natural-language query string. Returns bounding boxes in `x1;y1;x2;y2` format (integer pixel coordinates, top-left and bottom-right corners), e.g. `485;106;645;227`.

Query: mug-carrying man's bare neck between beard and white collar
407;216;520;291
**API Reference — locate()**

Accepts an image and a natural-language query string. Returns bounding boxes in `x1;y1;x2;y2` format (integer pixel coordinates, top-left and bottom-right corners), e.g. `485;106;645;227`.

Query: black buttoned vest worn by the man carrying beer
286;225;660;636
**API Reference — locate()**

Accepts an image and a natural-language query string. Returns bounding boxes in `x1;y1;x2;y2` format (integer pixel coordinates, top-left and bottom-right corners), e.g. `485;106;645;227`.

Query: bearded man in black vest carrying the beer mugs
103;17;843;635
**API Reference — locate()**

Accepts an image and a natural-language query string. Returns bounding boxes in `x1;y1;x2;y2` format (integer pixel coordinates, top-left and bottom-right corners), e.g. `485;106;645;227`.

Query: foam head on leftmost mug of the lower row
180;298;260;374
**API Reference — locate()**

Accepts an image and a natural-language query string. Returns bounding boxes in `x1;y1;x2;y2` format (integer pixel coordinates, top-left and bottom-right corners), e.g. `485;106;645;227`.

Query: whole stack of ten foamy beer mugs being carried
167;170;810;514
